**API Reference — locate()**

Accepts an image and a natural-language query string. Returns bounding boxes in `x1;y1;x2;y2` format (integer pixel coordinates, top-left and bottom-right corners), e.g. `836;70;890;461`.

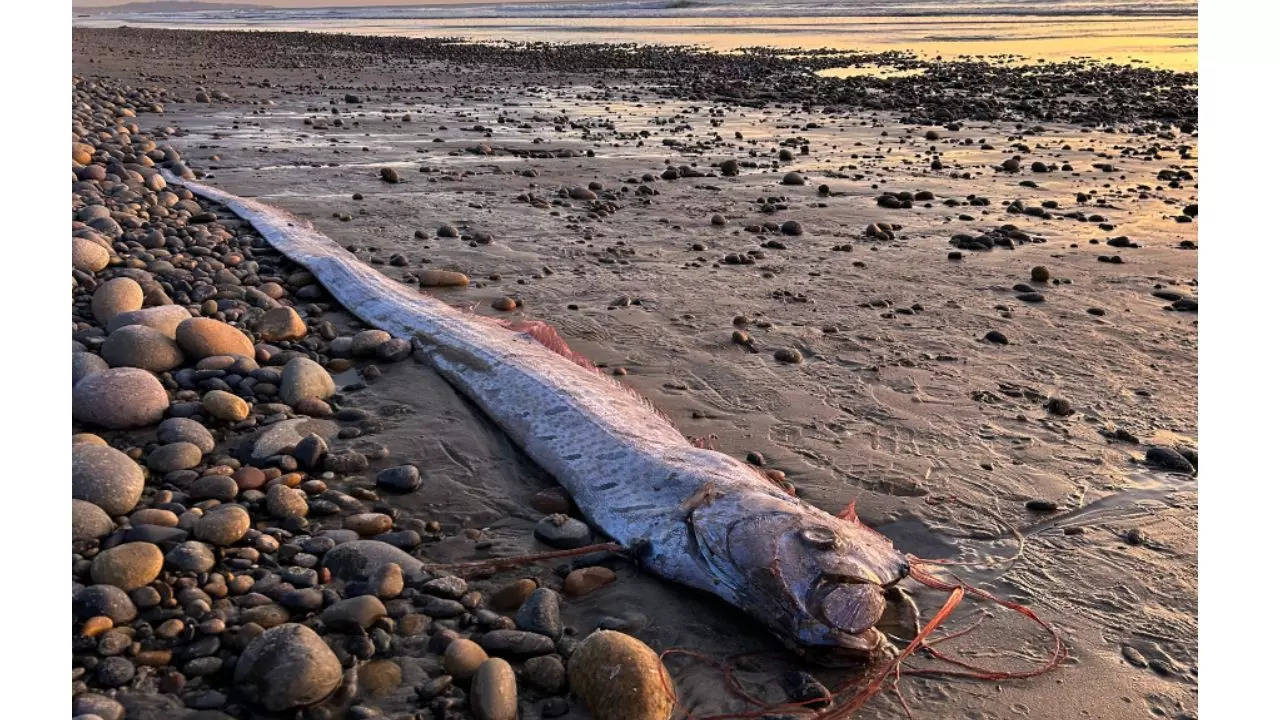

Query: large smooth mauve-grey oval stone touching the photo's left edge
72;368;169;429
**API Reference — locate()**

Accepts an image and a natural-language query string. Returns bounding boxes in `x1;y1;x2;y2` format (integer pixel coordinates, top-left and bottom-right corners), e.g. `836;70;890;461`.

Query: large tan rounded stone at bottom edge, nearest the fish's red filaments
568;630;675;720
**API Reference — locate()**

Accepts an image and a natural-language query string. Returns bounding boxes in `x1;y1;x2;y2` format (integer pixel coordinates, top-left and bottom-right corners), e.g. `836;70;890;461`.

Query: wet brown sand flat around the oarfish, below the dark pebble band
74;31;1198;717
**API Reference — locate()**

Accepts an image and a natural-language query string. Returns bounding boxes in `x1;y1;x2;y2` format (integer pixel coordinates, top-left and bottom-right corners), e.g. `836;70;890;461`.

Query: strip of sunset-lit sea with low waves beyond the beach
74;3;1198;70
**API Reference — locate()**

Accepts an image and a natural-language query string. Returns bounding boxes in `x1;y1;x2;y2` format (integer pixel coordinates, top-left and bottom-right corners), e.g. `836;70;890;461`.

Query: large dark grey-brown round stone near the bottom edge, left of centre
236;623;342;712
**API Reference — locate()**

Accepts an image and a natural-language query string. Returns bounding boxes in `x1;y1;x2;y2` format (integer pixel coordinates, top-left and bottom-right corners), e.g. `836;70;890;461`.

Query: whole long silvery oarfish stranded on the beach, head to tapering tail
165;173;909;659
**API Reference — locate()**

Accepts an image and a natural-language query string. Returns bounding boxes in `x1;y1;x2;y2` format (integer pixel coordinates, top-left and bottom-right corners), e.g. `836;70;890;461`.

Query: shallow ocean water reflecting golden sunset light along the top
73;0;1197;70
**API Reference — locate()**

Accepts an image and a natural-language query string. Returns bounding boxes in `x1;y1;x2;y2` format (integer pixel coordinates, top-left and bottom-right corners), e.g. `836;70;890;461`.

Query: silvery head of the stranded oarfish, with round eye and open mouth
689;498;910;664
